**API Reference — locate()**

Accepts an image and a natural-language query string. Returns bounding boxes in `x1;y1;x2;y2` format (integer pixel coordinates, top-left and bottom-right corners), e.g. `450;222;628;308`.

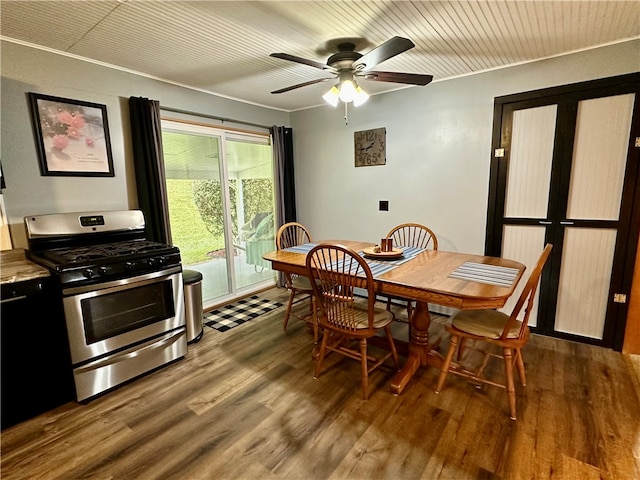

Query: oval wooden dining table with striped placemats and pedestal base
263;240;526;394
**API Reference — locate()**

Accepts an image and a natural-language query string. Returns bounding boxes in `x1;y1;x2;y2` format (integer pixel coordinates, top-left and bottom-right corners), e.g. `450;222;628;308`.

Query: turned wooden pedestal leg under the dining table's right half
391;302;442;395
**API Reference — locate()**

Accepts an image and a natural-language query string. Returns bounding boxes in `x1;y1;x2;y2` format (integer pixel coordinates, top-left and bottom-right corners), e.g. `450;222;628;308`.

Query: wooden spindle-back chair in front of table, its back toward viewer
306;243;399;400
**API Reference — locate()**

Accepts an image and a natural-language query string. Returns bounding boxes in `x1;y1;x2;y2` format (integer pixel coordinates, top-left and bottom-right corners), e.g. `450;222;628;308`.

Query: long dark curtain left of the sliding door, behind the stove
129;97;171;243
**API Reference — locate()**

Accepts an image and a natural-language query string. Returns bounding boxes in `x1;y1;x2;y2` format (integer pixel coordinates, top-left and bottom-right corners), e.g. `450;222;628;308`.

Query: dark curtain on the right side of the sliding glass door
269;125;296;227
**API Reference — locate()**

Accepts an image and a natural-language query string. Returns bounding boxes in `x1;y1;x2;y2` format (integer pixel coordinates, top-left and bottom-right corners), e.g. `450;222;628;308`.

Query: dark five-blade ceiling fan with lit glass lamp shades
270;37;433;106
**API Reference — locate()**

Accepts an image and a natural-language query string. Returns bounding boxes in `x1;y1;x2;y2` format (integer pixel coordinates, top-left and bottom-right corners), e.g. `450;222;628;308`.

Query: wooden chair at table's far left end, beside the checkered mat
276;222;319;343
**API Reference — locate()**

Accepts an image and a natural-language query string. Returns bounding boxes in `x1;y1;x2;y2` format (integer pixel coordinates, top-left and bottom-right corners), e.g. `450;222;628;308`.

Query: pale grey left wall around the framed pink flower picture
0;41;289;248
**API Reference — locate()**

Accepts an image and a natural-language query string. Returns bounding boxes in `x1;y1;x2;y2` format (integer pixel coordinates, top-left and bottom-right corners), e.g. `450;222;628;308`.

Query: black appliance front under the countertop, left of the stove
0;277;75;429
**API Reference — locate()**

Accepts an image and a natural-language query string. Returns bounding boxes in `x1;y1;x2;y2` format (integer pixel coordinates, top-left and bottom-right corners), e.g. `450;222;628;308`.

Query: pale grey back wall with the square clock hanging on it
291;41;640;253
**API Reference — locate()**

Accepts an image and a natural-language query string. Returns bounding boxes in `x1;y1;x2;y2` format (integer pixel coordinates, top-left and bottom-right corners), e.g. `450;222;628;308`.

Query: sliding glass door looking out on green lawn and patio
162;120;275;308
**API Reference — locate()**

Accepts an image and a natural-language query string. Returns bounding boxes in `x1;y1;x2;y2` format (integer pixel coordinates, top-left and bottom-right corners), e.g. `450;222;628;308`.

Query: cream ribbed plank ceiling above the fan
0;0;640;111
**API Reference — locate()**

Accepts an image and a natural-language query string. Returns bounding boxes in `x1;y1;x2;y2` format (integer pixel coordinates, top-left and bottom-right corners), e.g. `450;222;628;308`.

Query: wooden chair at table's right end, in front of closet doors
436;243;553;420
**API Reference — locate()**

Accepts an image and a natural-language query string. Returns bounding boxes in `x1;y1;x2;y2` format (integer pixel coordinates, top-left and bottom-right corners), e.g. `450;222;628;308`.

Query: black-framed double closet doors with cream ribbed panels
486;77;640;347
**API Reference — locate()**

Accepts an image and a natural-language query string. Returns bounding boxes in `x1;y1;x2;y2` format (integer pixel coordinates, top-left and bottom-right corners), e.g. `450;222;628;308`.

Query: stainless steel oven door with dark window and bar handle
62;267;185;366
